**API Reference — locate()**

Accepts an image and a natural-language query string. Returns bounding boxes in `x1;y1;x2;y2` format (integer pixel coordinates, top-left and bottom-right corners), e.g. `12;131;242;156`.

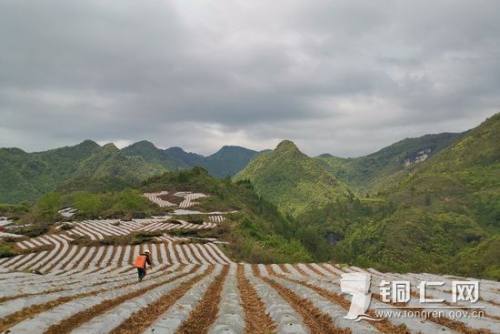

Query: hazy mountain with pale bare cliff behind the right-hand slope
317;133;463;192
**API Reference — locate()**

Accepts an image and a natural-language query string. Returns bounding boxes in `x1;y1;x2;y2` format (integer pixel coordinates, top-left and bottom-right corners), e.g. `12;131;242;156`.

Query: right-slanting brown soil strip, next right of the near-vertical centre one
252;265;351;334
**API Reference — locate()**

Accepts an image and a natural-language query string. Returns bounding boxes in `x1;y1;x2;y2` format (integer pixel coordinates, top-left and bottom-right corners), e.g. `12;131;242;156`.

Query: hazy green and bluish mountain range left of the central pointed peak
0;140;257;204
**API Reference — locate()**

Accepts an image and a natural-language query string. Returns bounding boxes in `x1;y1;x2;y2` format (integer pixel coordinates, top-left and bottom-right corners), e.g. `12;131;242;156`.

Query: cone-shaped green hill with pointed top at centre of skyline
235;140;353;216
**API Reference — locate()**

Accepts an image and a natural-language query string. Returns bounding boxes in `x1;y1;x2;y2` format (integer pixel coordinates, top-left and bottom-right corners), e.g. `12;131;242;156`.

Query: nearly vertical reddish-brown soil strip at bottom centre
236;265;276;334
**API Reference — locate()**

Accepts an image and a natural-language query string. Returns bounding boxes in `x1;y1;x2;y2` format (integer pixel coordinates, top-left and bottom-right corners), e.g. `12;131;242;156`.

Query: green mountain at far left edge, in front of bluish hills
0;140;166;203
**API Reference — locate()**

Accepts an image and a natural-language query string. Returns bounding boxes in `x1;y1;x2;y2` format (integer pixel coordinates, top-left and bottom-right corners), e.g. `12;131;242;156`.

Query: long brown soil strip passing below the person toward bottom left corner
45;267;197;334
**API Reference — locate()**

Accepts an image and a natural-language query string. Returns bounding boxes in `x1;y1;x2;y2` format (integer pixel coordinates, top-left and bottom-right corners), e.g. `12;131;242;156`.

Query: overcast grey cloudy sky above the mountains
0;0;500;157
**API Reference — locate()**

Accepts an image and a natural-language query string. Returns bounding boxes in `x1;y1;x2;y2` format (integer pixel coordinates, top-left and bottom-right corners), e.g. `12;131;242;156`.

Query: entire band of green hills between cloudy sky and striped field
0;114;500;279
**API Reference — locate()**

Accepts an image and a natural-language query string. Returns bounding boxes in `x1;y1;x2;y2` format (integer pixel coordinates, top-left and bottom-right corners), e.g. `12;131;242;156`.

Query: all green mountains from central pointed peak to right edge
236;114;500;279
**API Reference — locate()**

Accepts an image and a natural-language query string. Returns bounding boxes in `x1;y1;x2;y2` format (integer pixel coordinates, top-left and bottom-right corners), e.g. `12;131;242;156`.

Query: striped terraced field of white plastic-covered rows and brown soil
0;192;500;333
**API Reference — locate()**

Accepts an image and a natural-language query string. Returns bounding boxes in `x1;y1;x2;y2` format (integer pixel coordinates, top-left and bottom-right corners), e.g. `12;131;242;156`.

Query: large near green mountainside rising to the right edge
336;114;500;279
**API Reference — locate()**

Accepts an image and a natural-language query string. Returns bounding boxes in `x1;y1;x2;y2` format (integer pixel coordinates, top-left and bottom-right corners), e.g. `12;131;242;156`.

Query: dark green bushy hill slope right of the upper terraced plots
142;168;313;263
